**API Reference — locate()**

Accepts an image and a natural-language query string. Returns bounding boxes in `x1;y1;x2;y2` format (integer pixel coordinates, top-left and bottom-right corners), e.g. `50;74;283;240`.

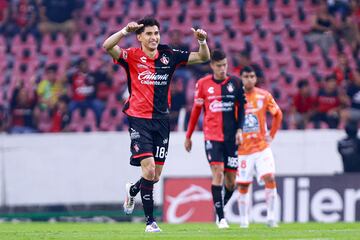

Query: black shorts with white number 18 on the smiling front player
128;116;170;166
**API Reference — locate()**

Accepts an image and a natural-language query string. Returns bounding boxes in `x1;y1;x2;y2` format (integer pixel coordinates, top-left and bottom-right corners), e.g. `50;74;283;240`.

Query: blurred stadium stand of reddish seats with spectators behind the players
0;0;360;133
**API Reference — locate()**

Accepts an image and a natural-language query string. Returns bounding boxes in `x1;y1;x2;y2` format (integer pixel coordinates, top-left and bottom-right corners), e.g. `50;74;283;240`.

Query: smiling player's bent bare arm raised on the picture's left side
103;22;143;59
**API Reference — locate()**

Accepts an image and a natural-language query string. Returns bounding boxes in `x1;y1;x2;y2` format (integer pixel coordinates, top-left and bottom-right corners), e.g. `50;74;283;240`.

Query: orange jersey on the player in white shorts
238;87;282;155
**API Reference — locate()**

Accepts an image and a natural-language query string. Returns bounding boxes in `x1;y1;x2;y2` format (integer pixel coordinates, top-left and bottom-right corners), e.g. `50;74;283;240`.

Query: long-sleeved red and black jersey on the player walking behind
186;75;246;141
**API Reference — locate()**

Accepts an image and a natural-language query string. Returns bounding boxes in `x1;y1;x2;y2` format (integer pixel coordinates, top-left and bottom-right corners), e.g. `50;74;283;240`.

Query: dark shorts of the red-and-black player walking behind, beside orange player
205;140;238;172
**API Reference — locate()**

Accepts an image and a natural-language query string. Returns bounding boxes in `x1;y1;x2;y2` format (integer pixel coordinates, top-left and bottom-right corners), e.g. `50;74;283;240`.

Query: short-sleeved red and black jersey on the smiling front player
116;45;189;119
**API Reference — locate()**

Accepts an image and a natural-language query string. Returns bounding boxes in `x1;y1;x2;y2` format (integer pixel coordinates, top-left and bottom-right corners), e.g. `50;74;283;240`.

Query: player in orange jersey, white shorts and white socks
236;66;282;228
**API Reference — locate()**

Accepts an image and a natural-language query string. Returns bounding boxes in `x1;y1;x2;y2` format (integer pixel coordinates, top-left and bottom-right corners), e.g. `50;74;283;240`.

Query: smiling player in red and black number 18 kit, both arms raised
103;17;210;232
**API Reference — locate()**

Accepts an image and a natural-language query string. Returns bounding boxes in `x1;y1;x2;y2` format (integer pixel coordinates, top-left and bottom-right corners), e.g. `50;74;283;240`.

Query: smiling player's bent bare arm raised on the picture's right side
187;28;210;64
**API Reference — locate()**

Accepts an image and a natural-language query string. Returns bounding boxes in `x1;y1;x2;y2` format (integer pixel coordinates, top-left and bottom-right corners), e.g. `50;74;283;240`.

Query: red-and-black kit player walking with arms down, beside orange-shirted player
185;50;246;228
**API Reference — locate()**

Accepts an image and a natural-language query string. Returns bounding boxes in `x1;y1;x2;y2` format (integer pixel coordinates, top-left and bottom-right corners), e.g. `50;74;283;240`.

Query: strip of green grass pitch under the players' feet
0;223;360;240
